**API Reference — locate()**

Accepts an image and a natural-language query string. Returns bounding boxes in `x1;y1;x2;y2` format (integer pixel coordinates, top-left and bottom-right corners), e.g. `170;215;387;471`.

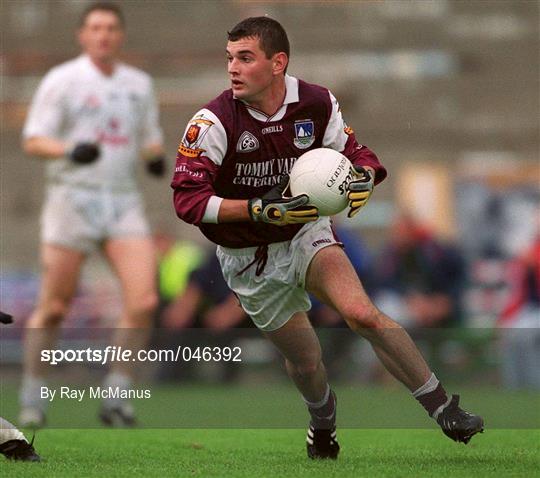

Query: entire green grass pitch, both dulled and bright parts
0;382;540;478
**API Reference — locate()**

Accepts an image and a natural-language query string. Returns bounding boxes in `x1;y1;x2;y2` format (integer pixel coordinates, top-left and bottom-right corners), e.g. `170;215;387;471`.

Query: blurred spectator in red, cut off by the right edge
498;234;540;389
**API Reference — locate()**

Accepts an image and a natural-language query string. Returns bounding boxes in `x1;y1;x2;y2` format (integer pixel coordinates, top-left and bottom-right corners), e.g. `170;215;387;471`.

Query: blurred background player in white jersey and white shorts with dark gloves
20;3;165;427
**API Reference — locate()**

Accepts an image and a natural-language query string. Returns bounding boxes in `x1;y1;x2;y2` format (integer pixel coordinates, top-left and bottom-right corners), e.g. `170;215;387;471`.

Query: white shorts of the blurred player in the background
41;184;150;253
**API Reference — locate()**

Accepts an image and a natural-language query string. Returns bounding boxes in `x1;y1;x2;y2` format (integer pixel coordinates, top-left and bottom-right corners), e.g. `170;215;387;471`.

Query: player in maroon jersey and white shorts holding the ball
172;17;483;459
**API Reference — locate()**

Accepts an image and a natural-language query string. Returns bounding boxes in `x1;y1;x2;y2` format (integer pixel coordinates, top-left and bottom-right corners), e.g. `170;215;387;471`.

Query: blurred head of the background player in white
79;10;124;61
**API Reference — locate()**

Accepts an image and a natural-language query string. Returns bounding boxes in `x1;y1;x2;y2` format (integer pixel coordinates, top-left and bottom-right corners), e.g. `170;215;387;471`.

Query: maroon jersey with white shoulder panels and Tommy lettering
171;76;386;248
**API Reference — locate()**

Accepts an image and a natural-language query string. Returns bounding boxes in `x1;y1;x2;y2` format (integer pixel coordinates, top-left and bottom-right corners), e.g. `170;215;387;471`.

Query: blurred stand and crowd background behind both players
0;0;540;388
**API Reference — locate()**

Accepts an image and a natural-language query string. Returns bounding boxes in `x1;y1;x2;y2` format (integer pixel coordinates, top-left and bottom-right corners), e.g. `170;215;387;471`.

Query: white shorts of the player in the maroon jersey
217;217;341;332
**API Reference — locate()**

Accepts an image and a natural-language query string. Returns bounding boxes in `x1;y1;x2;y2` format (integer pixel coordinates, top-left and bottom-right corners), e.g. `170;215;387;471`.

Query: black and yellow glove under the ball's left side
248;176;319;226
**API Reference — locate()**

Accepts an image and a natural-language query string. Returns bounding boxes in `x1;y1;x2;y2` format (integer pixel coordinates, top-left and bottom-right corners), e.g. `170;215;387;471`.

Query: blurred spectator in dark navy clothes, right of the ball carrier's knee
375;214;465;330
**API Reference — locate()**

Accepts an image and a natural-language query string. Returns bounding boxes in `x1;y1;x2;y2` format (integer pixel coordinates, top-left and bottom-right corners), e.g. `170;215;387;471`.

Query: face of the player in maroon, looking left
227;37;274;102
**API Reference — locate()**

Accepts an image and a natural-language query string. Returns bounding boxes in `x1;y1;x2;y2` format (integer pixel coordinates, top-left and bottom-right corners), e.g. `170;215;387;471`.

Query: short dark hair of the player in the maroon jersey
227;17;290;58
